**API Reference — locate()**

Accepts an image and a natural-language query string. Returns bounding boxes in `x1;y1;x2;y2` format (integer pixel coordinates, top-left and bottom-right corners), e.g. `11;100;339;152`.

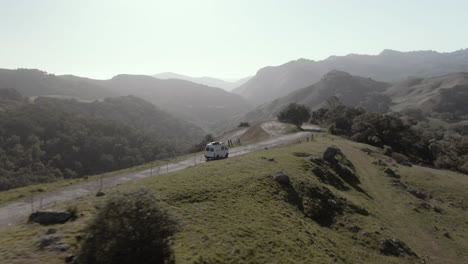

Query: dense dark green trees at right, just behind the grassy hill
311;104;468;173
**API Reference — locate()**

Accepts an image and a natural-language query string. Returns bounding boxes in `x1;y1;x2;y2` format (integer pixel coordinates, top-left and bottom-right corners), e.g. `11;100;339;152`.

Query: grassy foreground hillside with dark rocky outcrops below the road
0;134;468;263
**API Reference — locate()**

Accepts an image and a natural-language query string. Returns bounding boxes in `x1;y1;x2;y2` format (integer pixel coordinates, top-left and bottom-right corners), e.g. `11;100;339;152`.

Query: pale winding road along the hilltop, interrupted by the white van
0;125;320;228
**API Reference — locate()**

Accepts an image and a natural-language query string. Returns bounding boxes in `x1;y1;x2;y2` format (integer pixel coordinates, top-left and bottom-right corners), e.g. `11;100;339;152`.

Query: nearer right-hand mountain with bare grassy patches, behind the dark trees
243;70;468;123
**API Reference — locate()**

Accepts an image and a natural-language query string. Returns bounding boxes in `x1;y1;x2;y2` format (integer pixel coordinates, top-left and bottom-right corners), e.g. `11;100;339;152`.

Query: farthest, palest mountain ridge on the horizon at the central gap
152;72;252;91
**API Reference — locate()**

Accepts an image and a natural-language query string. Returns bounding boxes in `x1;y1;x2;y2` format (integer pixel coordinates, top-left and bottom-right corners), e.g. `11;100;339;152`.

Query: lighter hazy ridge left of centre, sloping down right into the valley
104;74;250;129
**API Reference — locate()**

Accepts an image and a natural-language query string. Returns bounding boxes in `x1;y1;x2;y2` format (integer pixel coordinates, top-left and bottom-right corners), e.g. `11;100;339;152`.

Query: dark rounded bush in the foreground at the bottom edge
77;190;178;264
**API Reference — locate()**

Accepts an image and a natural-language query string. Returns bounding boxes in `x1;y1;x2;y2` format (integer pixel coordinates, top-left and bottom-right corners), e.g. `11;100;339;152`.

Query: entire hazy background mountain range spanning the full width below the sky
0;49;468;132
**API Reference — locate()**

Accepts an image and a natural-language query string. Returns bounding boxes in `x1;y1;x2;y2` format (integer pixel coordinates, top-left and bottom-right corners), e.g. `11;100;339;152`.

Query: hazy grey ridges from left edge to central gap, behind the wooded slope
0;69;250;132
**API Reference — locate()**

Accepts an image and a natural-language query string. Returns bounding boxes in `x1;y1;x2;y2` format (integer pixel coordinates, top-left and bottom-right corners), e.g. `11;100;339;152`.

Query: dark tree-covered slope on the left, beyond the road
0;91;202;190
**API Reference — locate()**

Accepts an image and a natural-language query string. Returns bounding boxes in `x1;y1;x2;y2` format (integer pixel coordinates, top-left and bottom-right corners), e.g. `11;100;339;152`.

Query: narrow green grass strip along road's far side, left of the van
0;154;195;205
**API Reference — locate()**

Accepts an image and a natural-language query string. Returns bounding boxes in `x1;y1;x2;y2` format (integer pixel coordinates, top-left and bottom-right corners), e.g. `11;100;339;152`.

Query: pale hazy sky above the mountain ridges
0;0;468;79
